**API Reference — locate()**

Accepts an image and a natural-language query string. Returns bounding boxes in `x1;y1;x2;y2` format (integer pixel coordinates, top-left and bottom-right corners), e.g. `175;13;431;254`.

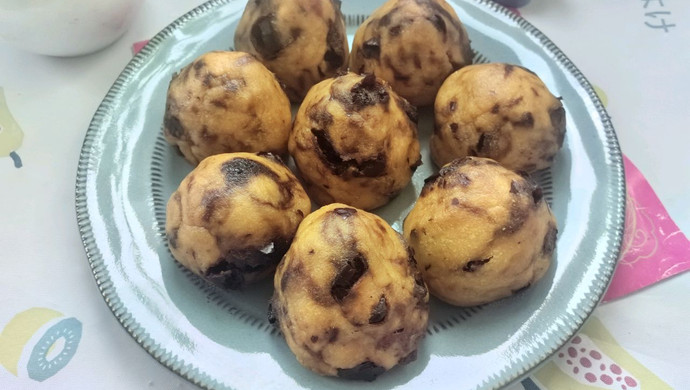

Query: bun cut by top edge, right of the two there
350;0;472;106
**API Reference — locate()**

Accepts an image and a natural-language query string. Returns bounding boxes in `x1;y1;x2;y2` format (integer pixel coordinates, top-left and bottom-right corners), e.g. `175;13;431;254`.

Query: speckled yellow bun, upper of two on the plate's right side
431;63;565;172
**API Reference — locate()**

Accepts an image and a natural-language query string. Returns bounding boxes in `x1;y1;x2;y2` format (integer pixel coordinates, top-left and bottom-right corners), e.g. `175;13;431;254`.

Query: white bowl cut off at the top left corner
0;0;144;56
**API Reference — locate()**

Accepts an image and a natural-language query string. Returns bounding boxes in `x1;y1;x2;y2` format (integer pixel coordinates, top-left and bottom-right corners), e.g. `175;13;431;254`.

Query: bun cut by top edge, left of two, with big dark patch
235;0;348;102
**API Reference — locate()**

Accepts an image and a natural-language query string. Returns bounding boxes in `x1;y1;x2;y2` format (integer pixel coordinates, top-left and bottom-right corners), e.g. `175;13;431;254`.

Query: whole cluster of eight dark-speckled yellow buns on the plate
163;0;565;380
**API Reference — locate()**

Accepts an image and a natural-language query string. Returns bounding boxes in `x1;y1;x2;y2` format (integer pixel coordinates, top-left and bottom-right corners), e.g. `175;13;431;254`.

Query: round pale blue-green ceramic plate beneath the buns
76;0;625;389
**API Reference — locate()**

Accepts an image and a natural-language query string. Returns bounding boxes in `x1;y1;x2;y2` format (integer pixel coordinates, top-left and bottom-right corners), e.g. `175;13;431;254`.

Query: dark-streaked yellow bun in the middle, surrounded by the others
288;73;421;210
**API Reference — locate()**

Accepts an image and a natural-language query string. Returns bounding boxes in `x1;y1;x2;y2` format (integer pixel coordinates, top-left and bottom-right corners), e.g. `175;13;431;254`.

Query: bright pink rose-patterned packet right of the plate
603;156;690;302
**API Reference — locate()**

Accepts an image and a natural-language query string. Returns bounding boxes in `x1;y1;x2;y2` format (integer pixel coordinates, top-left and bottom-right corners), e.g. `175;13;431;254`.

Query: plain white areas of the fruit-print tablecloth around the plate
0;0;690;389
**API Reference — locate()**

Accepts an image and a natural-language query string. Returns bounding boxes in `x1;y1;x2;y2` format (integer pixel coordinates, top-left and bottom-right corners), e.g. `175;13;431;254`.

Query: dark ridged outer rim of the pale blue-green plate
75;0;626;389
